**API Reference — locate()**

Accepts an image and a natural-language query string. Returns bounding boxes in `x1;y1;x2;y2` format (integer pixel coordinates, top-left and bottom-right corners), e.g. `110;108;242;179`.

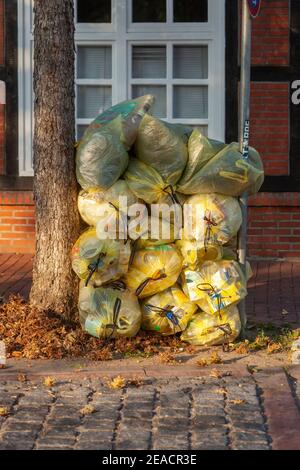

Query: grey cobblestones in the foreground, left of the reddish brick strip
0;375;288;450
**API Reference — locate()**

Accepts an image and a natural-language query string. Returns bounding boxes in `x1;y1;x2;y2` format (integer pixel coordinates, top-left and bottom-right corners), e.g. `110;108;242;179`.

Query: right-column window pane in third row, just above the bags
174;85;208;119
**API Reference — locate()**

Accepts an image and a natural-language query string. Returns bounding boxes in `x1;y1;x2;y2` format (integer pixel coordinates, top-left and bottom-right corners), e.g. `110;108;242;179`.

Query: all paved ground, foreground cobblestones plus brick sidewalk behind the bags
0;255;300;450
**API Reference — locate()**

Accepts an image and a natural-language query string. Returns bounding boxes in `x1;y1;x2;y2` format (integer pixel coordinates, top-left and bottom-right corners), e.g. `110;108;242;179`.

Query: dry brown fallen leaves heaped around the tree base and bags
0;296;191;361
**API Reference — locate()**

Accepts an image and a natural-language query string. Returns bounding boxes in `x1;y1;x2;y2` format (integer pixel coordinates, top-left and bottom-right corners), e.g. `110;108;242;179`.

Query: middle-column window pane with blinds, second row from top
132;46;167;78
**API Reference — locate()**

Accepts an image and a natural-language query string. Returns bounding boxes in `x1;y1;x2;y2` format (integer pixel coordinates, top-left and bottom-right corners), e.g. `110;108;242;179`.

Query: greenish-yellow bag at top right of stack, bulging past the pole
177;142;264;196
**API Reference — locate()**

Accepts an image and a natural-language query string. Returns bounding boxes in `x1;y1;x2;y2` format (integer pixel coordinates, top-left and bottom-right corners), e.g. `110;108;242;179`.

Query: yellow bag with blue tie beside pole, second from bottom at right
184;260;247;314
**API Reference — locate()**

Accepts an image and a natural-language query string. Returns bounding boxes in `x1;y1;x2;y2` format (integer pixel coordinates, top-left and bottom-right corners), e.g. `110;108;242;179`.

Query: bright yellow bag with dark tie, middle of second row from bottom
124;245;182;298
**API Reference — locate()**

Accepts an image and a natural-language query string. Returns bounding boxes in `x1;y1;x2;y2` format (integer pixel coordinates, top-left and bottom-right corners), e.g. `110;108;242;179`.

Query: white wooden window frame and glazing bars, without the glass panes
18;0;225;176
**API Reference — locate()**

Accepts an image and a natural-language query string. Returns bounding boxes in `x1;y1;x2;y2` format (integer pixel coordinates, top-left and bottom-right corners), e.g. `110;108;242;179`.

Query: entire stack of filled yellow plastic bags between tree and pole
72;95;264;346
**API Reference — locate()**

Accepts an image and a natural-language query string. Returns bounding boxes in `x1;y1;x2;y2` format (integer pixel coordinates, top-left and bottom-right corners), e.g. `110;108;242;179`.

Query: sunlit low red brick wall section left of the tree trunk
0;191;35;253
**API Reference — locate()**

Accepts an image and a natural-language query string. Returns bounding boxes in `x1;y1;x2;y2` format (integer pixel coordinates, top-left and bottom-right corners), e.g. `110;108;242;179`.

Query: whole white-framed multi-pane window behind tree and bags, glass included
18;0;225;175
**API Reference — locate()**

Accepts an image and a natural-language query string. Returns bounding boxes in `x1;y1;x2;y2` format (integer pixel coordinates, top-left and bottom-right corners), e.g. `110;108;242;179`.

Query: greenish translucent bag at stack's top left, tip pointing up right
76;95;154;190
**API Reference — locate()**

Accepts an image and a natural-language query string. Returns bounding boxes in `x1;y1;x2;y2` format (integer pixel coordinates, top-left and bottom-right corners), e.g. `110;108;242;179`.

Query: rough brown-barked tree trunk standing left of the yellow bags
30;0;79;318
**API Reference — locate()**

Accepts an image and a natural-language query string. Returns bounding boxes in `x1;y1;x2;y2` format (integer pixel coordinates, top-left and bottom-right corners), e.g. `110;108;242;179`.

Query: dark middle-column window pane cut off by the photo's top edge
132;0;167;23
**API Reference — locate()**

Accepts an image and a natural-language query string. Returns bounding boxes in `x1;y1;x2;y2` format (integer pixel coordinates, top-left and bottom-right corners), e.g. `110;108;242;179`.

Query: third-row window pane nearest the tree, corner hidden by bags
77;86;111;119
